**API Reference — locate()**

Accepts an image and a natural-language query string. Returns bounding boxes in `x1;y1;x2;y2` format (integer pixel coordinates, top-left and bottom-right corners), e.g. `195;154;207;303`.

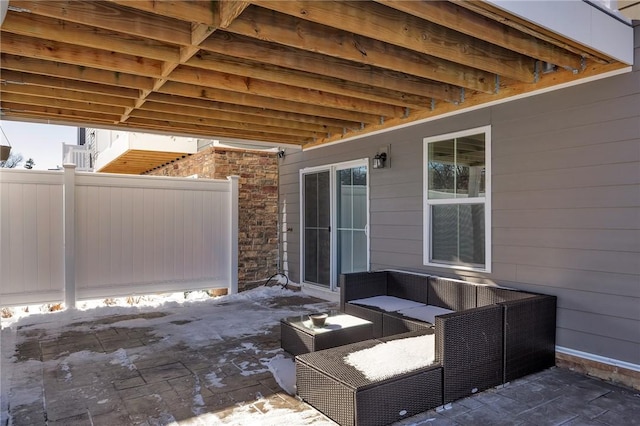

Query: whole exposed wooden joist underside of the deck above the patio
0;0;628;153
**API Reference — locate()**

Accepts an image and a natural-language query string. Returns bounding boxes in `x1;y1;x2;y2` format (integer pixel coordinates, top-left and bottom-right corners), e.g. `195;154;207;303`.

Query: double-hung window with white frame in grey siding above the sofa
424;126;491;272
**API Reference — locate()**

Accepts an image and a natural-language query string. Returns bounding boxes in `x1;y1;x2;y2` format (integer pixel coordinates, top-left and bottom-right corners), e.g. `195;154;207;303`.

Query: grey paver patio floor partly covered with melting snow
0;289;640;426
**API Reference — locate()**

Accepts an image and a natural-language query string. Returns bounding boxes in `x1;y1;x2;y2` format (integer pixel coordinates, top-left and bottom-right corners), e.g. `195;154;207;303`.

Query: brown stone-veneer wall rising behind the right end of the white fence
148;147;278;289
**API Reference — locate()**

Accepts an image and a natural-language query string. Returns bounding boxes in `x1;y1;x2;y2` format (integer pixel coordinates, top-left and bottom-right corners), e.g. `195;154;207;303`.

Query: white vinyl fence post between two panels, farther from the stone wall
62;164;76;309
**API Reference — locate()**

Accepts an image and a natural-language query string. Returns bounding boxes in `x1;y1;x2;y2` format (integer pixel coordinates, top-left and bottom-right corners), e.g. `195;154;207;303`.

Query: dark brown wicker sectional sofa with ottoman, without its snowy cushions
296;271;556;425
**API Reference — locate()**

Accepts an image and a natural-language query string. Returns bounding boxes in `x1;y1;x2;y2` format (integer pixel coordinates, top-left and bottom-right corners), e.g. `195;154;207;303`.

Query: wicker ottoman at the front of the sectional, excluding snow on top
296;339;442;425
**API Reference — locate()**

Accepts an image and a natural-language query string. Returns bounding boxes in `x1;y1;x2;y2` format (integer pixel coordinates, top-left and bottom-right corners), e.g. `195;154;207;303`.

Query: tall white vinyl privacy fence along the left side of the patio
0;165;238;307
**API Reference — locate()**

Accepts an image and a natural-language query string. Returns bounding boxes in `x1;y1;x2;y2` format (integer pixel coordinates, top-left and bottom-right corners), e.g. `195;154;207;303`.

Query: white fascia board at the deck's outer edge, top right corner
485;0;633;65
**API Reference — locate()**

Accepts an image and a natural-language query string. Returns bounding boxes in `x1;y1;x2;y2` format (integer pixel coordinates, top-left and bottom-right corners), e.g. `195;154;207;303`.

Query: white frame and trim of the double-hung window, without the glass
422;126;492;272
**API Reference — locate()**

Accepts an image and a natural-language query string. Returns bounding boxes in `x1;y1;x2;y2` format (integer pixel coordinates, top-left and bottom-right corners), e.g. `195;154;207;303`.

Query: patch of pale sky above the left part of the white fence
0;120;78;170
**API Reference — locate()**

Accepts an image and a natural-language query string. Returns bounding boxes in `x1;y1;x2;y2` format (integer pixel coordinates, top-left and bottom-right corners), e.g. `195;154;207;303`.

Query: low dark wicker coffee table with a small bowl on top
280;312;373;355
